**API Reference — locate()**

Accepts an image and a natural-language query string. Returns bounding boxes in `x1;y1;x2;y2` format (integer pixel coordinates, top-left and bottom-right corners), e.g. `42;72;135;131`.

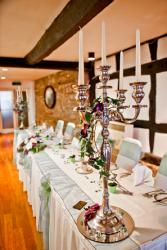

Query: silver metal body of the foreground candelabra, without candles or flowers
76;65;146;242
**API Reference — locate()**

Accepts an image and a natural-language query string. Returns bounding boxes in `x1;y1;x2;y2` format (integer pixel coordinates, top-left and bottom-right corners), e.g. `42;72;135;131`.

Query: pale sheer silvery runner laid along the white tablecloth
33;152;138;250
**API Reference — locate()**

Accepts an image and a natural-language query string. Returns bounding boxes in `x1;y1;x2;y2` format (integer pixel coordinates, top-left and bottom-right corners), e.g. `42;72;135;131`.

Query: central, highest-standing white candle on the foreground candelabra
101;22;107;66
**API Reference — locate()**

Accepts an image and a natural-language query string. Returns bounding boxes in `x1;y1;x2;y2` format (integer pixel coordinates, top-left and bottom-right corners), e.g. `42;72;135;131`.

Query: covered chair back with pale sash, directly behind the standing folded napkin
116;138;142;171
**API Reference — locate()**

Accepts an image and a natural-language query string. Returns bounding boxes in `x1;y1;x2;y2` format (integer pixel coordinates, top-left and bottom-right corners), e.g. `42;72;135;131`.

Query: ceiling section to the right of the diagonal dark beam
47;0;167;61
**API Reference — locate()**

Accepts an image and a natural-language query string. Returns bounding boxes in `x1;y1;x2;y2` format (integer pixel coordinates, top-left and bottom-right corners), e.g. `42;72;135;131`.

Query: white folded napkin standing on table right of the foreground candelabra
133;163;154;187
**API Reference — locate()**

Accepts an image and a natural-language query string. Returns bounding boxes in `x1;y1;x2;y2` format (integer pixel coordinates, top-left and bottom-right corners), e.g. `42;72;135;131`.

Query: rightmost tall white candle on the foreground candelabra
136;30;141;81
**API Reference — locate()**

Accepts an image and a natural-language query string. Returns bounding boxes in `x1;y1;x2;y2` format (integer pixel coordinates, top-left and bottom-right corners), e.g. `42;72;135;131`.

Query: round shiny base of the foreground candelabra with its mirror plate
77;206;134;243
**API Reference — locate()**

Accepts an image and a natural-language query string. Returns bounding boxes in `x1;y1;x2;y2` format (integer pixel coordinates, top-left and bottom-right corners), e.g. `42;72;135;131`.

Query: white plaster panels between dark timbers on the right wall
95;37;167;156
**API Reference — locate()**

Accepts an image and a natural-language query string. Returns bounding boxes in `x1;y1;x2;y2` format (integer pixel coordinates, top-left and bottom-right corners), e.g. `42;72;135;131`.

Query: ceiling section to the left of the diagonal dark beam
0;0;69;57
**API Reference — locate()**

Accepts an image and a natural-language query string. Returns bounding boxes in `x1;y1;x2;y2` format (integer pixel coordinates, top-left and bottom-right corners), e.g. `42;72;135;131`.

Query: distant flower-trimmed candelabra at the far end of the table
14;86;27;129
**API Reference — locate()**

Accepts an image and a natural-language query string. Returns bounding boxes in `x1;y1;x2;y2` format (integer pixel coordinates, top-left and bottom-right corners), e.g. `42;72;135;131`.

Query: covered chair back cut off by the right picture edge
155;153;167;191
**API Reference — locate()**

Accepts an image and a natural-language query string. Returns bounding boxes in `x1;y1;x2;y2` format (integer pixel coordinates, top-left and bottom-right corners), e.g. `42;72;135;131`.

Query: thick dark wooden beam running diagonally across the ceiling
25;0;113;65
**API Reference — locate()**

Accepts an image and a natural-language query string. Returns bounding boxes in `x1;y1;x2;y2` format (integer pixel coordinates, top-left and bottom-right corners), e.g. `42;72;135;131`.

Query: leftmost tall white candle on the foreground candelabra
78;30;84;85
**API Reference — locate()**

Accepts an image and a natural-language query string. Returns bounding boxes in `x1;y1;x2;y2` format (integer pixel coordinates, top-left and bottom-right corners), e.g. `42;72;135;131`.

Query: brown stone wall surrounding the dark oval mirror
35;71;79;126
